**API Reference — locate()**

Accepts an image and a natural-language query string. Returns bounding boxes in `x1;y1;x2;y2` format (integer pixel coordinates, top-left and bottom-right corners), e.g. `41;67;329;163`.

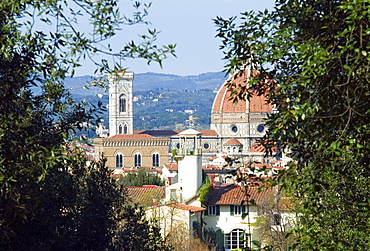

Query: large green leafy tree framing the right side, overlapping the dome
215;0;370;250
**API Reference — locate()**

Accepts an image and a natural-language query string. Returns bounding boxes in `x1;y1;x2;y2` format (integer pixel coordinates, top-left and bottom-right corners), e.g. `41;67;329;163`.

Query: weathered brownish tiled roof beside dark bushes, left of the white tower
125;186;166;206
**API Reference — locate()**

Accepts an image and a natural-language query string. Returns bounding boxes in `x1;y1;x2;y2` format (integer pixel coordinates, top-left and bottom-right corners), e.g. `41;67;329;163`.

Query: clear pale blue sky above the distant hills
76;0;274;76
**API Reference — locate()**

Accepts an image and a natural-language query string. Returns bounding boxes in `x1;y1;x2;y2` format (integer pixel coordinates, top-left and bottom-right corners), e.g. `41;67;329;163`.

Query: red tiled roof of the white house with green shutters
206;185;271;205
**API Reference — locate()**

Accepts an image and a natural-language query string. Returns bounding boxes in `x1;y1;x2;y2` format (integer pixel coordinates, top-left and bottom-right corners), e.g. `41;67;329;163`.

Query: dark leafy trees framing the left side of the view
0;0;174;250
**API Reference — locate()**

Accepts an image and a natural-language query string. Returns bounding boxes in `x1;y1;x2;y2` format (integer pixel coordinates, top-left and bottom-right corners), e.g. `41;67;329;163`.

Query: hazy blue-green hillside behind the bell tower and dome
65;72;226;133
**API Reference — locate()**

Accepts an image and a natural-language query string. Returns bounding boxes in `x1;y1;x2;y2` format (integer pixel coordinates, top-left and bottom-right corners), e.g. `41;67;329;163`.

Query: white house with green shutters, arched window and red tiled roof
203;184;294;251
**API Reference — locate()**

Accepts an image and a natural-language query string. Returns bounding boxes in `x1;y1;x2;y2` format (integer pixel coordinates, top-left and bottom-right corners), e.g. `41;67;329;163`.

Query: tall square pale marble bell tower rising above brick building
108;71;134;136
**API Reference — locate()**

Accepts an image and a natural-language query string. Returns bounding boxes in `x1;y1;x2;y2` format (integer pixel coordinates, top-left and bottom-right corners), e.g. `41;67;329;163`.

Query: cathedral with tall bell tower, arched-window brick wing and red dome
94;70;275;173
